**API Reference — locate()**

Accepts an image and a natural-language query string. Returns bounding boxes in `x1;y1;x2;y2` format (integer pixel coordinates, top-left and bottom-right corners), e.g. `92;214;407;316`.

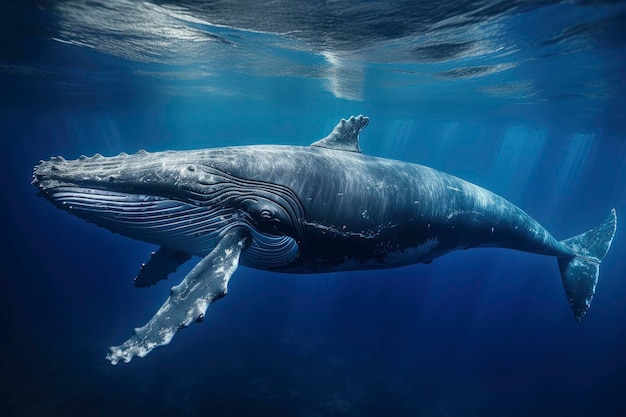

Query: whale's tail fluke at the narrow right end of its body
559;209;617;321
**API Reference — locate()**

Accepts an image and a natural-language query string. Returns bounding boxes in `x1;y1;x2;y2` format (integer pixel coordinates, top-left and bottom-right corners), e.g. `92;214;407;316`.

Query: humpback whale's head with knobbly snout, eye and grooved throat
33;148;302;268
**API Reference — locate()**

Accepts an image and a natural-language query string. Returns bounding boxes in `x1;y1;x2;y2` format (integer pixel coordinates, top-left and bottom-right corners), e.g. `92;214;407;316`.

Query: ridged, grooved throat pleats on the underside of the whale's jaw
51;187;298;268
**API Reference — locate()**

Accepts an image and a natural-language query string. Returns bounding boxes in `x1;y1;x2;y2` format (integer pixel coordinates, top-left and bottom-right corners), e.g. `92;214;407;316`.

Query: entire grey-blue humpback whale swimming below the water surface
32;115;617;365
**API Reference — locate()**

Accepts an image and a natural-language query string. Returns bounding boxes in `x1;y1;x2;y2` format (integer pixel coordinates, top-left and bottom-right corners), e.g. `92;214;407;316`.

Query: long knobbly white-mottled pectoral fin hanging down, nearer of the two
106;227;250;365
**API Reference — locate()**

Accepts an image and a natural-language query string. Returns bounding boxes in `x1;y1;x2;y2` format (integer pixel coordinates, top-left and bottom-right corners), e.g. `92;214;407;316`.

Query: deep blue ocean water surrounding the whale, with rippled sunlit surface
0;0;626;417
